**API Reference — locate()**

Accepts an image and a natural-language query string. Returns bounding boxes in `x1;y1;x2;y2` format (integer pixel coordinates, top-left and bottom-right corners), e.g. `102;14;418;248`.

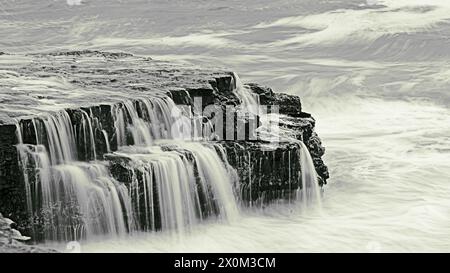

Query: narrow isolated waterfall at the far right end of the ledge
297;141;321;207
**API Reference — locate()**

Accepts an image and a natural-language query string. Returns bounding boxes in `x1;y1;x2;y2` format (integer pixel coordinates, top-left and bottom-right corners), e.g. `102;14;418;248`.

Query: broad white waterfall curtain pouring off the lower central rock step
114;140;238;233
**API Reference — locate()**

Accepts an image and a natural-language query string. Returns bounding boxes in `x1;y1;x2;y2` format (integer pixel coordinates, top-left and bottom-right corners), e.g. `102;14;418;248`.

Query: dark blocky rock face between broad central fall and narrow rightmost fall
220;141;301;203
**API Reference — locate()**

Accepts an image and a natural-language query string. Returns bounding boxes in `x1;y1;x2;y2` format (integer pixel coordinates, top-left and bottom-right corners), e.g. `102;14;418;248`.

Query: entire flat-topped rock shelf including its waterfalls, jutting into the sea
0;51;328;241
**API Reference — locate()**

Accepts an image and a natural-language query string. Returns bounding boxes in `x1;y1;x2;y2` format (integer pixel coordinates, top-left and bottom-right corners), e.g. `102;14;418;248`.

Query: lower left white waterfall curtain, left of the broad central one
48;163;133;240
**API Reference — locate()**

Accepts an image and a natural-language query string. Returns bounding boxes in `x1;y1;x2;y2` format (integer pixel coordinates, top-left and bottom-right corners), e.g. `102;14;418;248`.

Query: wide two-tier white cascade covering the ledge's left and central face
16;95;238;241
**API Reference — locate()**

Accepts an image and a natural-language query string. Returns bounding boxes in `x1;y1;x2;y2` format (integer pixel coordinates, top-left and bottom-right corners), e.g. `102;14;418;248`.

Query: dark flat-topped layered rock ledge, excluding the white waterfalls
0;51;328;240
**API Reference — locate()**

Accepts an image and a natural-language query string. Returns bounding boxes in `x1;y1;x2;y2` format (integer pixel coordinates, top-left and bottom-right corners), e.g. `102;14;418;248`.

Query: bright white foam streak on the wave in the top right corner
255;1;450;46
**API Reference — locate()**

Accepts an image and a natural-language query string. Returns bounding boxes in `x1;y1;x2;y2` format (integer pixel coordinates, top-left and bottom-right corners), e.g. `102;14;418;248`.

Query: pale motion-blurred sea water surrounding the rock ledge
0;0;450;252
